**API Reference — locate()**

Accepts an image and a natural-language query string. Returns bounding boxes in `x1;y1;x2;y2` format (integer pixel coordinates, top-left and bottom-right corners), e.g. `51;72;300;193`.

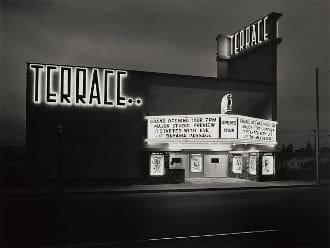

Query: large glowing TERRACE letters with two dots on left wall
28;64;143;108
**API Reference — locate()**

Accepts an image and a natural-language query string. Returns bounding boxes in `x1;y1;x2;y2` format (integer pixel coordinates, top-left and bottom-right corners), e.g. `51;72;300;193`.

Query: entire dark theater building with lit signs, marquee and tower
26;13;281;183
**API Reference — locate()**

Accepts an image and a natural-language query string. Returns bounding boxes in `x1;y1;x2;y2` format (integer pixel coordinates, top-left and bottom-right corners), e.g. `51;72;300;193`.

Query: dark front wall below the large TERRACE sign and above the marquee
26;67;276;177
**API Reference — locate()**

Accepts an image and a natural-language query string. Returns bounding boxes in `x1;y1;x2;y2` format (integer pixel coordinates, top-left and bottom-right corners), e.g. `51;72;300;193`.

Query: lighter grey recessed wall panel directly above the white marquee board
149;85;272;120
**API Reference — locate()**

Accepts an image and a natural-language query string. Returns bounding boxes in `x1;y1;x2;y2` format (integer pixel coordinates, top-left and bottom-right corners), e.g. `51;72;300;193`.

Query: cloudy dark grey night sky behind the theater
0;0;330;147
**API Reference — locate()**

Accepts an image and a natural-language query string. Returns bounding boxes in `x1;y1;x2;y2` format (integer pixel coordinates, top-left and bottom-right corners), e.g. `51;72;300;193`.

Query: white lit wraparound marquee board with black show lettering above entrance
146;114;277;143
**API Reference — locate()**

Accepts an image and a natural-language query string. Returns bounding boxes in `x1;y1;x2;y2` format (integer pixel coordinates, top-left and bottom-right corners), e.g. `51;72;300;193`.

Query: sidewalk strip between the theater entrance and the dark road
1;178;330;195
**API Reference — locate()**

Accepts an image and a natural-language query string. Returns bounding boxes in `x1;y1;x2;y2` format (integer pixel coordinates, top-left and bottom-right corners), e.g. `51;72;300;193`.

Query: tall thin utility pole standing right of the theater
315;68;320;185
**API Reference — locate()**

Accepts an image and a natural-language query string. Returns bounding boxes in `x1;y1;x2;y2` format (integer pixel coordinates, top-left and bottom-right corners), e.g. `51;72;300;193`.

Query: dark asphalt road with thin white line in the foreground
2;186;330;247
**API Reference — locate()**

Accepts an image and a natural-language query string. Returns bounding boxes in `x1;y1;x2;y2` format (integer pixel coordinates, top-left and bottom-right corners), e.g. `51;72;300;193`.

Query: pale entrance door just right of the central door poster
204;154;228;177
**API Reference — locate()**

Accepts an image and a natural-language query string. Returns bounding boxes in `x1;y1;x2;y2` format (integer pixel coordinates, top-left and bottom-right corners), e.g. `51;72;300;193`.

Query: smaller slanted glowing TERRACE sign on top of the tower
229;16;269;55
